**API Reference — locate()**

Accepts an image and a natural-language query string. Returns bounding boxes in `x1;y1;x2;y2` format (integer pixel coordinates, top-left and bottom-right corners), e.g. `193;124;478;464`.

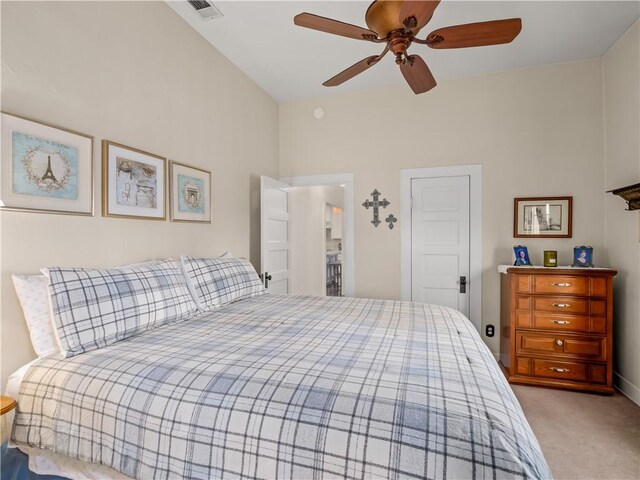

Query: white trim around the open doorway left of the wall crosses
280;173;356;297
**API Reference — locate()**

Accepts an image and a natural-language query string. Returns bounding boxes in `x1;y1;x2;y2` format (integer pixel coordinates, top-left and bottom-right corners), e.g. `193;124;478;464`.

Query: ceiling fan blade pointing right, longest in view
426;18;522;48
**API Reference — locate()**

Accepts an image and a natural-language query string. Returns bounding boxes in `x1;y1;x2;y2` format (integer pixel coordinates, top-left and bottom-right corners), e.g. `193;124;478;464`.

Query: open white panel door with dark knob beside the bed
260;176;291;293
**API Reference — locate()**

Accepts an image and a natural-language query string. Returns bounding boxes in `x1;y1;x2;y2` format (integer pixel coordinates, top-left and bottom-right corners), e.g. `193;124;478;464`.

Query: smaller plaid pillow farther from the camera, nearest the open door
182;255;266;310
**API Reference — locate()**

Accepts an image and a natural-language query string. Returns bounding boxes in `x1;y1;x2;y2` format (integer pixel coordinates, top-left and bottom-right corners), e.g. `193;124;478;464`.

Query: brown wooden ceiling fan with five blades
293;0;522;94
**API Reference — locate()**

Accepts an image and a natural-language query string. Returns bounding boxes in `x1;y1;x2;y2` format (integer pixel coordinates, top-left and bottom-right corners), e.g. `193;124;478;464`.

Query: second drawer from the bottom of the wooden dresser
516;331;606;360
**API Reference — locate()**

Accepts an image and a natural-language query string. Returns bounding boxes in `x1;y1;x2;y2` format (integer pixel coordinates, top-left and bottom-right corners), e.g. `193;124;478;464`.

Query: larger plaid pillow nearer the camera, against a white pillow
49;260;197;357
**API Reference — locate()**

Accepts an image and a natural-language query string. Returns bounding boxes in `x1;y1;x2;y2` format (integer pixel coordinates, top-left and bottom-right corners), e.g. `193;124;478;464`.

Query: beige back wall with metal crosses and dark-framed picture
280;59;605;352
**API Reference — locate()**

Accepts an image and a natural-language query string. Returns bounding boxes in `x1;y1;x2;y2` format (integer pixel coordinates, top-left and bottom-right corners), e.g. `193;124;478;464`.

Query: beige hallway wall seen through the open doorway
290;186;344;296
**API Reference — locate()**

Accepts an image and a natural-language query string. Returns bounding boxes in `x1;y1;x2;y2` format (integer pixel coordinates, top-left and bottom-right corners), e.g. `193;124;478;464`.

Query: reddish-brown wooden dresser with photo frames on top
500;267;617;393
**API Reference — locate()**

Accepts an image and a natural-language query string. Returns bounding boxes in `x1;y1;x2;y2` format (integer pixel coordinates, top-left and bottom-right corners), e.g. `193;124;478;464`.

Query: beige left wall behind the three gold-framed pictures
0;2;278;386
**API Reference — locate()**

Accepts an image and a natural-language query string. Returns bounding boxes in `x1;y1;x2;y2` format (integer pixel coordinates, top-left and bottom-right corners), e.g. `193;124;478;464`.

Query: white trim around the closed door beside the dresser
400;165;482;333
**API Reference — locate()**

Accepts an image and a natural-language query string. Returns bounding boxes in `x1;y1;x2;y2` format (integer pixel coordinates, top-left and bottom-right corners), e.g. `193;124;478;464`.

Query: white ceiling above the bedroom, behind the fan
167;0;640;101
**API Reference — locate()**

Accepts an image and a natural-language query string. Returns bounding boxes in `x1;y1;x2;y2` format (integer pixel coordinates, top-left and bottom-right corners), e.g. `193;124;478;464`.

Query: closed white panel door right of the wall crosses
411;176;470;317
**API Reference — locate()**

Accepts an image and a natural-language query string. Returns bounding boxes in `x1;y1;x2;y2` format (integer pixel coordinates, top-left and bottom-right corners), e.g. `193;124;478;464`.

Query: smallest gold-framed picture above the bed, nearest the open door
169;161;211;223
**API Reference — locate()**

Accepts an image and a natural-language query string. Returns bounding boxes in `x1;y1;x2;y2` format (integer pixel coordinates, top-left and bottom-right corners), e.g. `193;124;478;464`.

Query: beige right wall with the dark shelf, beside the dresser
603;18;640;403
